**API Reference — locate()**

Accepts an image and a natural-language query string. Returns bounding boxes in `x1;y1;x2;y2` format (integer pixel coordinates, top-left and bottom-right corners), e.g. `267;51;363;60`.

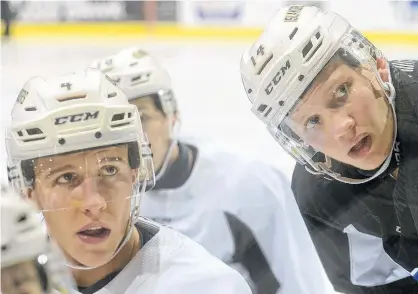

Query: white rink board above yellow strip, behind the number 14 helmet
179;0;418;33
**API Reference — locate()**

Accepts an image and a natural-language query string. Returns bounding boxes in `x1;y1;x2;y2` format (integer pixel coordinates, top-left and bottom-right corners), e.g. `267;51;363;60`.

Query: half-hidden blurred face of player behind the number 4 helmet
130;97;170;170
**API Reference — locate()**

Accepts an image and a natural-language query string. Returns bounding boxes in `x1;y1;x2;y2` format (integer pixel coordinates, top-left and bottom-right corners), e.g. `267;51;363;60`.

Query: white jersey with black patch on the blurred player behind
141;141;333;294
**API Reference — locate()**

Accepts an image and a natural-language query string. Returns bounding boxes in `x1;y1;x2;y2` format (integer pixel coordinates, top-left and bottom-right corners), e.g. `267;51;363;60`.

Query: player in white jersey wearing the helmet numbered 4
6;69;250;294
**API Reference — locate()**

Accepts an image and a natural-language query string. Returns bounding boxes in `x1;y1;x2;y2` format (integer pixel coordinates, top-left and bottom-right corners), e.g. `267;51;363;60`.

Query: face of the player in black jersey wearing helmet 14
290;62;393;170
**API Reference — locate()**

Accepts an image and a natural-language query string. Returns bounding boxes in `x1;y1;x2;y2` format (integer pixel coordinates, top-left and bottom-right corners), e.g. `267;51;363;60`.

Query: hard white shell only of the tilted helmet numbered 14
240;5;351;126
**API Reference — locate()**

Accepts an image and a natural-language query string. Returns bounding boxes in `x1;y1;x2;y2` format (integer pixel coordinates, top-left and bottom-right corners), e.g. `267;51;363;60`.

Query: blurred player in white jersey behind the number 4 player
92;48;334;294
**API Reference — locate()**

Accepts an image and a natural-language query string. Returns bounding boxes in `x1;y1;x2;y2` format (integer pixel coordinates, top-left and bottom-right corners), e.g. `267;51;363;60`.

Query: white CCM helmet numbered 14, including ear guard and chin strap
240;5;390;184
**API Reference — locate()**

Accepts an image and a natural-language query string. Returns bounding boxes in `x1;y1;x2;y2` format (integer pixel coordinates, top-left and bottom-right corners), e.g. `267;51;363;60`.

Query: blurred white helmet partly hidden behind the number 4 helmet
90;47;177;116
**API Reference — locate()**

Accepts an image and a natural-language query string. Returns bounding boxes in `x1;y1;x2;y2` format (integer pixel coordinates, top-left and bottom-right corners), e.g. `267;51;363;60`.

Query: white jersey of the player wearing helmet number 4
73;218;251;294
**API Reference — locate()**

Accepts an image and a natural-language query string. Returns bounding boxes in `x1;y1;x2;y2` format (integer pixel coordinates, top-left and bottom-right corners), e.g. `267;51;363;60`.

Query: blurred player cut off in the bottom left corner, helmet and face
0;189;75;294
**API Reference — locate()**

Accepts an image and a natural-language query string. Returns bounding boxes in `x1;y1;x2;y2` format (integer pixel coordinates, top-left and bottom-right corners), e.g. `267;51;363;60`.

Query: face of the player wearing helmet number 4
30;146;136;266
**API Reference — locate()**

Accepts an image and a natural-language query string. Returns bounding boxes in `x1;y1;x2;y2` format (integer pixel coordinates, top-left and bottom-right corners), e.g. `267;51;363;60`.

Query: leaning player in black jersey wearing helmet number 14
241;6;418;294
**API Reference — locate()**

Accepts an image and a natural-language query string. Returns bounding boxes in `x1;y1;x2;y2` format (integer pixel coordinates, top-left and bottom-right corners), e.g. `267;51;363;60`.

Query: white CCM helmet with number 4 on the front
5;68;155;210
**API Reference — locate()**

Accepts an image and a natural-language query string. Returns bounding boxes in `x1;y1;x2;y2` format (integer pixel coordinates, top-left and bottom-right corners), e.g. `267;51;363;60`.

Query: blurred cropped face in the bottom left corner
1;261;43;294
